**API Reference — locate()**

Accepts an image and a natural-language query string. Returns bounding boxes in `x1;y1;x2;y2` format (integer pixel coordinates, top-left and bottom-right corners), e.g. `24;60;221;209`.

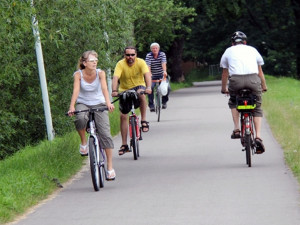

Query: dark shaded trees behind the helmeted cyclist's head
184;0;300;78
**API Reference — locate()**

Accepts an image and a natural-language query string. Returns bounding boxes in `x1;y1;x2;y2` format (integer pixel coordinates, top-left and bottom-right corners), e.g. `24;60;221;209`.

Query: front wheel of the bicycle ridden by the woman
89;137;100;191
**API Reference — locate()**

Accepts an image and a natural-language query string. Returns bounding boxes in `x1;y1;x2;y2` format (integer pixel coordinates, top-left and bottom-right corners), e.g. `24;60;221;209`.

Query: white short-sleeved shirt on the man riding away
220;44;264;76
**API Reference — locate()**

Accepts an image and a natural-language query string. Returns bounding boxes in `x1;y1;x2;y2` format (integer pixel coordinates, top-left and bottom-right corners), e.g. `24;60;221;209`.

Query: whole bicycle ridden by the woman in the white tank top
66;106;108;191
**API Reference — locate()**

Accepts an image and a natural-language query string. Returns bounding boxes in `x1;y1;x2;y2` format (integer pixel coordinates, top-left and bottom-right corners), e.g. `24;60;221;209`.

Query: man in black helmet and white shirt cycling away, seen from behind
220;31;267;154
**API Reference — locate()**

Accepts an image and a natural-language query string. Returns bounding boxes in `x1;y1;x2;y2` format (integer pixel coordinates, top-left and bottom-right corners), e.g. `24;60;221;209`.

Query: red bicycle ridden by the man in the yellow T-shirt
113;90;145;160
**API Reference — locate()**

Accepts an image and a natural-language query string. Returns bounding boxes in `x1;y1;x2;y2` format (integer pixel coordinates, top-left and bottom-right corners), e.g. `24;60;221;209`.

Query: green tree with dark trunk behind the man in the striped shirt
130;0;196;81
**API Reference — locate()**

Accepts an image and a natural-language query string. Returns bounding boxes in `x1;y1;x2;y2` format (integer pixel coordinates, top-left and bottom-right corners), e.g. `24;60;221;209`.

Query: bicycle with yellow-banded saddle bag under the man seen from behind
236;89;257;167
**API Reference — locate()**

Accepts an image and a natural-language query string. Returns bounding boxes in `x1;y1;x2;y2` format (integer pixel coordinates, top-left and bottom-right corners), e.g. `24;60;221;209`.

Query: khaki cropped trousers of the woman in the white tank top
74;103;114;149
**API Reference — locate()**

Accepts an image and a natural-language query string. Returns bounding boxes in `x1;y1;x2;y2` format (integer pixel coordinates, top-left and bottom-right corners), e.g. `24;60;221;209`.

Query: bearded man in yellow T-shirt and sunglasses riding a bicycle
112;46;152;155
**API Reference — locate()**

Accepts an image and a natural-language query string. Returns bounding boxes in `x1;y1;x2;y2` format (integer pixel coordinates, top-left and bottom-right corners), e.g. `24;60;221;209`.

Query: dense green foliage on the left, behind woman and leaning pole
0;0;133;158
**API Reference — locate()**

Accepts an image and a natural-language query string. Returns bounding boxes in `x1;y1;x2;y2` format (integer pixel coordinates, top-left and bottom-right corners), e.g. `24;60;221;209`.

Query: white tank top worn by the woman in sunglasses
73;69;105;105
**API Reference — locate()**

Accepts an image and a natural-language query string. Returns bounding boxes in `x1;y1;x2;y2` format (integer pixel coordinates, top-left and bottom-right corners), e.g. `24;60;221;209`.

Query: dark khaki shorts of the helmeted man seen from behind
228;74;263;117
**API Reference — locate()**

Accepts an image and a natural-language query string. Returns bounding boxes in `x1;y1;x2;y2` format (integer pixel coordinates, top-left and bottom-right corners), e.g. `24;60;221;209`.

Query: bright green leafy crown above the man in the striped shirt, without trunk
133;0;196;56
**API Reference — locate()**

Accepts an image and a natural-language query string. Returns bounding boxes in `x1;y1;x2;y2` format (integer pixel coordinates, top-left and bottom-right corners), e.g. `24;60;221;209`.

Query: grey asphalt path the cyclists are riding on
14;82;300;225
